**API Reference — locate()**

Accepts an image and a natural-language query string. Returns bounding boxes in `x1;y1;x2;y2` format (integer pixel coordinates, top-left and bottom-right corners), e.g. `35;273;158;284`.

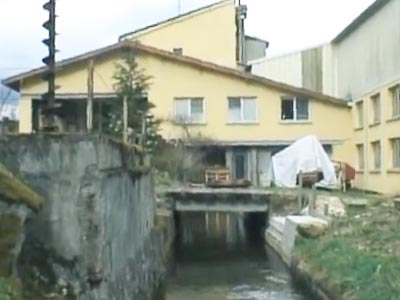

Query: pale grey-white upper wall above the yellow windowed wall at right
334;0;400;99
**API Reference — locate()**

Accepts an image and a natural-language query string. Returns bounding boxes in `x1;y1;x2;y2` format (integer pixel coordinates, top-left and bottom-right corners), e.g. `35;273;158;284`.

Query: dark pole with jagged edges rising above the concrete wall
42;0;57;131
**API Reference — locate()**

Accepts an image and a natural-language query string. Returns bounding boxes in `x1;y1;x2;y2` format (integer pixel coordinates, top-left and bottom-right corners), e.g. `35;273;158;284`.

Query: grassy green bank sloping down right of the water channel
296;200;400;300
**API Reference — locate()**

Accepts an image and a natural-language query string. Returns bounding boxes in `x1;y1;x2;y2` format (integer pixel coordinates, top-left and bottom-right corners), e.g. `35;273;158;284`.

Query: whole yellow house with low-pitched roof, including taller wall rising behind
4;1;354;185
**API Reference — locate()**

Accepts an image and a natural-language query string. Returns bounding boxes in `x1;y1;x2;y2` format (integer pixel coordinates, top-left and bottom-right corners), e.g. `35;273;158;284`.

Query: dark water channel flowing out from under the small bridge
166;213;314;300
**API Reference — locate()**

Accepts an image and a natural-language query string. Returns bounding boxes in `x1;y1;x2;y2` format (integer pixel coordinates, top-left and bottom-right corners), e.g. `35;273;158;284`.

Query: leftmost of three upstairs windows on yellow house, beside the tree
174;98;204;124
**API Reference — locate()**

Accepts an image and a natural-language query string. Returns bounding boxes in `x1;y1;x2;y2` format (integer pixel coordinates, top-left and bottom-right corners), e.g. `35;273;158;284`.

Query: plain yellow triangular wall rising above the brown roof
119;0;237;68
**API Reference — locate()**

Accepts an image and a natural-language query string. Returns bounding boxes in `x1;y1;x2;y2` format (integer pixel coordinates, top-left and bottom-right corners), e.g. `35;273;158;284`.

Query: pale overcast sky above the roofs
0;0;373;78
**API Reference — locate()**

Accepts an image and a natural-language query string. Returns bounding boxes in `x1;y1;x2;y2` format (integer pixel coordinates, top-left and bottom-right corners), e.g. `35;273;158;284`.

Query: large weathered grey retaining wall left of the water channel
0;135;165;300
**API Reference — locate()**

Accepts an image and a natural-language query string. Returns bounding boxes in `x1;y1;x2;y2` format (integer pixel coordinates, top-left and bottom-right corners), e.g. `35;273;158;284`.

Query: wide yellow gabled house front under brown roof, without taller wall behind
2;41;352;185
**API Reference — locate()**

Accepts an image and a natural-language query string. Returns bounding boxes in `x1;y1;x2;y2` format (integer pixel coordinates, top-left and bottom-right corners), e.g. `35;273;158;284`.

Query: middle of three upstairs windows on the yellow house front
228;98;257;123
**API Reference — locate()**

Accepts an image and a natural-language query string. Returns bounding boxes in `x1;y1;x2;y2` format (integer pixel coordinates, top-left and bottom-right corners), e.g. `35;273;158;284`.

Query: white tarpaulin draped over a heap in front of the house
268;135;338;188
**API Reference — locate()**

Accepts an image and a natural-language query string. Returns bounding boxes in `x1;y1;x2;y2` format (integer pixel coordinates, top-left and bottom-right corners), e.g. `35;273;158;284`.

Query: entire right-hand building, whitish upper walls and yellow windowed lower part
252;0;400;194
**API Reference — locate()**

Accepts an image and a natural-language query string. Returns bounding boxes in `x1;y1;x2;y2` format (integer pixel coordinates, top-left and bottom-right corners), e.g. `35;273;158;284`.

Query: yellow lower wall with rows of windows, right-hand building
353;80;400;194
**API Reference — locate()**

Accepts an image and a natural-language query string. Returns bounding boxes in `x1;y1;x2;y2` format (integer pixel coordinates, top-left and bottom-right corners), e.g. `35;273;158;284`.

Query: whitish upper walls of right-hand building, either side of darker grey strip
253;0;400;100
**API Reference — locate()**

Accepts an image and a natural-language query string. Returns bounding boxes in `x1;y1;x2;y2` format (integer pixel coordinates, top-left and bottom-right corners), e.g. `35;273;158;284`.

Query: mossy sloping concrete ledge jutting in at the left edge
0;163;44;210
